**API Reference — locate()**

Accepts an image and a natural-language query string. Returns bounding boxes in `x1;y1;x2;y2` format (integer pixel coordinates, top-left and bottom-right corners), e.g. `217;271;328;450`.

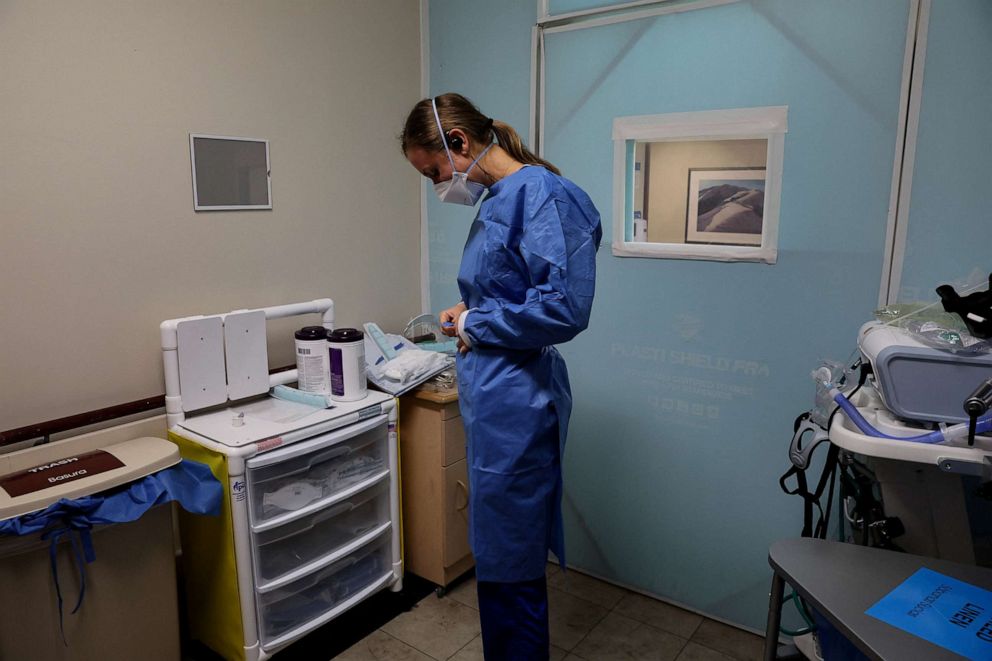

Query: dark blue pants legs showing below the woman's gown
478;576;551;661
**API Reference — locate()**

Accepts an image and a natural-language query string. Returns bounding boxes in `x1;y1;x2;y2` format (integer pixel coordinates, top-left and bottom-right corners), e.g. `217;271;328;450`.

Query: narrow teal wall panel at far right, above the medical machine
898;0;992;301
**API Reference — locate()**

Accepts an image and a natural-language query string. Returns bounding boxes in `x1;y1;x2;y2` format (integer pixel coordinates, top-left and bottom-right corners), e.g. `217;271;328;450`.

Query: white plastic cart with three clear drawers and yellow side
162;299;403;660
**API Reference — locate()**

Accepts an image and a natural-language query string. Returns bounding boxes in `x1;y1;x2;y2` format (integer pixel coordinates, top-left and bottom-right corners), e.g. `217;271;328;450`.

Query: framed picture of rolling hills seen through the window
685;167;765;246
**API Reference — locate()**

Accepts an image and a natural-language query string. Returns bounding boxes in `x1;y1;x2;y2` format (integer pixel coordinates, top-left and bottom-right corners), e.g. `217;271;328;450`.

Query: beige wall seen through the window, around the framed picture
648;140;768;243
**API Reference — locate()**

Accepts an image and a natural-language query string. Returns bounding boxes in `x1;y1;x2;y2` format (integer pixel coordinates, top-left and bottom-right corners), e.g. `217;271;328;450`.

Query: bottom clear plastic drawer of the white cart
258;534;392;645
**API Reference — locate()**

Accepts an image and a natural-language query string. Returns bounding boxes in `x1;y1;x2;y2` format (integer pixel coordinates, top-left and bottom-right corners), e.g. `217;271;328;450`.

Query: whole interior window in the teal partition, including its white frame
613;108;785;263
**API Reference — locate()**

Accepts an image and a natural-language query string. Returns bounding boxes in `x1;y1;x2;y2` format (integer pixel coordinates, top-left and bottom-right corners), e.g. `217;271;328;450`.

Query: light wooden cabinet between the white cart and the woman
400;391;475;587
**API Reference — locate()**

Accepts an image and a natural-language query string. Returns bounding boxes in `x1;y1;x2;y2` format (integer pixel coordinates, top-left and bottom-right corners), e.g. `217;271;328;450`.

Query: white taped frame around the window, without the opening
613;106;789;264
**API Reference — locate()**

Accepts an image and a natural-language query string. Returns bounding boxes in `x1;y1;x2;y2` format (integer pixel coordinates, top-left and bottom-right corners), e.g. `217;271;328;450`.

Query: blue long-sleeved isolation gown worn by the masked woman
457;166;603;582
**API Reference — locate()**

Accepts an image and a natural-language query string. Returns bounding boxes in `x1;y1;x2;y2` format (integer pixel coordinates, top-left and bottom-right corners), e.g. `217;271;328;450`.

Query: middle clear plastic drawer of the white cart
252;479;390;586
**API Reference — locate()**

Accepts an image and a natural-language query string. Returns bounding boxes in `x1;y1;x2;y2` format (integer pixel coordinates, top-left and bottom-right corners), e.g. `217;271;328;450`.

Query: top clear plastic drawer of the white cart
247;416;389;525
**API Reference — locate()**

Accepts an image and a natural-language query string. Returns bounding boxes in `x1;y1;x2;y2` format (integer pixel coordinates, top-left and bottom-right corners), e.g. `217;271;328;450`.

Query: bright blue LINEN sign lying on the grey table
865;569;992;660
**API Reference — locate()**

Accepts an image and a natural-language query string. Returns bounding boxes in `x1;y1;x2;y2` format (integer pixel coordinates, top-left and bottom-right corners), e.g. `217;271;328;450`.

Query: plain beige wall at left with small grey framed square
0;0;420;431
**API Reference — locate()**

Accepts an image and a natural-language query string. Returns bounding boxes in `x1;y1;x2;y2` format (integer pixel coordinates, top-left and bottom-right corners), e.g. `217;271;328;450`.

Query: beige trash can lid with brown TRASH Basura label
0;436;181;521
